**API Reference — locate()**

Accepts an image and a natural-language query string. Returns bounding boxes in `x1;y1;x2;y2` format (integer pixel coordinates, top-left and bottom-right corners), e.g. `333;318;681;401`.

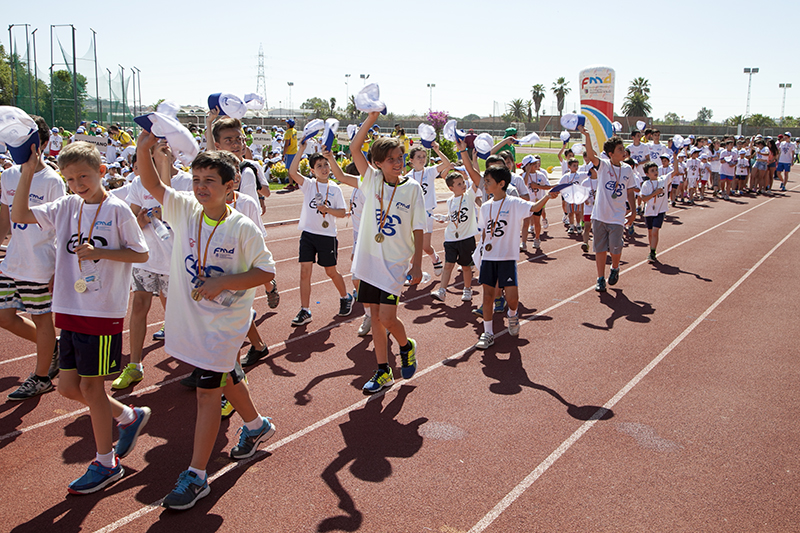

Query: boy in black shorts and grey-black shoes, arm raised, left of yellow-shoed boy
289;140;353;327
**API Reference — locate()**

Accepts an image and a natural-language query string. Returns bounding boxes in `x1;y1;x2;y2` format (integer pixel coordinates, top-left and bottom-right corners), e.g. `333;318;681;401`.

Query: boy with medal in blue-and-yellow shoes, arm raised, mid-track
344;112;427;394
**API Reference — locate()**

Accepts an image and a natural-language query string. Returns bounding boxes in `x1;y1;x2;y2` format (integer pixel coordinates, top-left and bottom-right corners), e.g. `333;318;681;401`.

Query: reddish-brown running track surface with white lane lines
0;173;800;533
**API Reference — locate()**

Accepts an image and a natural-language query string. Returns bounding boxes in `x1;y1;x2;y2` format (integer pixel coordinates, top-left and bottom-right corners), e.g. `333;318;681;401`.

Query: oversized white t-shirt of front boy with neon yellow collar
164;187;275;372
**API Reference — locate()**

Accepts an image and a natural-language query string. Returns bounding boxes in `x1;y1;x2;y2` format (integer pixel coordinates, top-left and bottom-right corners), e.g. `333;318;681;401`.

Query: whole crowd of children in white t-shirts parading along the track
0;102;797;509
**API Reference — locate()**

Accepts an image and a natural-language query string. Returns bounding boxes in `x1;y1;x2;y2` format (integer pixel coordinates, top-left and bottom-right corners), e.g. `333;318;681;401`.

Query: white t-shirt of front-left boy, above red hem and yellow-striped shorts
31;194;148;318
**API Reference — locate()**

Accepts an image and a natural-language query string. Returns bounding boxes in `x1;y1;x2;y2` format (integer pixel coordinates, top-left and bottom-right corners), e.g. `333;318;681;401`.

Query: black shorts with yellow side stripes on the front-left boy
58;329;122;378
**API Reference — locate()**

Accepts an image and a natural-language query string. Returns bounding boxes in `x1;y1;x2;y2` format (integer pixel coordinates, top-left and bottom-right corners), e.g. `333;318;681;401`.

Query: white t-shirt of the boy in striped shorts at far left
0;165;67;283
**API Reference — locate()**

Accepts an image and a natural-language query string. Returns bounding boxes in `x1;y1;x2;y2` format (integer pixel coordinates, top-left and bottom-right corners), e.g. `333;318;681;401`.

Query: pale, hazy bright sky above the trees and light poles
6;0;800;121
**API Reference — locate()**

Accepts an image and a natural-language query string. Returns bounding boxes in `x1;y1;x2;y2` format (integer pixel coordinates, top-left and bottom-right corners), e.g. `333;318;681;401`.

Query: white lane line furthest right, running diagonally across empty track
469;220;800;533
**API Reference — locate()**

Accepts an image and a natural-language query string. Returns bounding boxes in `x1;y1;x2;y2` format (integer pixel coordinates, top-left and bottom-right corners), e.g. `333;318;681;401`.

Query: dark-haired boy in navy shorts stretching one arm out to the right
476;163;558;350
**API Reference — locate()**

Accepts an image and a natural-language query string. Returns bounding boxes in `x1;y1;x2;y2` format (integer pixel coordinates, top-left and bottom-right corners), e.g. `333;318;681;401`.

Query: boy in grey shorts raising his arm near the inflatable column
578;126;636;292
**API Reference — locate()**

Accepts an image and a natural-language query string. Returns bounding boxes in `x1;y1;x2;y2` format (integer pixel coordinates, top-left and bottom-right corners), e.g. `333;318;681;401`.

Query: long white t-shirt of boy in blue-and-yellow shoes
351;167;428;296
